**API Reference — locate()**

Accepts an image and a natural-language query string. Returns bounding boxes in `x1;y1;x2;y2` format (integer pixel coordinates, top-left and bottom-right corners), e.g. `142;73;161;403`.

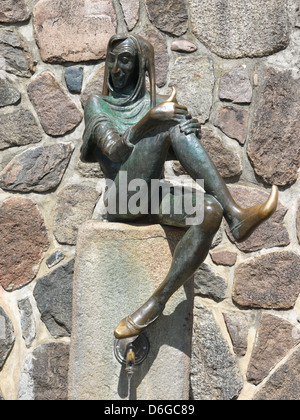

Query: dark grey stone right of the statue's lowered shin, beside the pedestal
194;264;227;302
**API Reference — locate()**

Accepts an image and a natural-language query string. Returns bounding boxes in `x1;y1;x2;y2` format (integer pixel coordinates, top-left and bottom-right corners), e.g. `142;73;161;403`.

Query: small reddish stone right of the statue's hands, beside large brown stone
215;106;249;144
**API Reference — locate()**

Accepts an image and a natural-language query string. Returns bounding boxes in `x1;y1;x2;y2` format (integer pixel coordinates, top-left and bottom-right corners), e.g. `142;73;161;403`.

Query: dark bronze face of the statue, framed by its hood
108;39;137;91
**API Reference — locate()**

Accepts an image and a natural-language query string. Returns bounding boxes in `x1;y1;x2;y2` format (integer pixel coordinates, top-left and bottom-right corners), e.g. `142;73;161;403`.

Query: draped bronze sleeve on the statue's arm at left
81;96;134;163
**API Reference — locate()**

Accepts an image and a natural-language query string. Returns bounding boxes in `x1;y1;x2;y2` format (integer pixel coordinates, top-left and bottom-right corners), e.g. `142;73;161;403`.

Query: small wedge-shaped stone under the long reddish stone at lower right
223;312;249;357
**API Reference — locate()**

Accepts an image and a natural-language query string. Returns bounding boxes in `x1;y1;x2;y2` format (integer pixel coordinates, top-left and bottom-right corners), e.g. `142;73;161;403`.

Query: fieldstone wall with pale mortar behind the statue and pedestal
0;0;300;400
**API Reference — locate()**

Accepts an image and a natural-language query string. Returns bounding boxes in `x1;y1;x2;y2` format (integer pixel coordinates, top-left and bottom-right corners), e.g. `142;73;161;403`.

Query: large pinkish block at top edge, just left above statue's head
34;0;117;63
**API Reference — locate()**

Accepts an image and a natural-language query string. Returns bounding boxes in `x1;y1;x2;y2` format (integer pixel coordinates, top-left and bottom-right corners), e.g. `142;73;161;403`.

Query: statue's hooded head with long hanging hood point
103;34;156;107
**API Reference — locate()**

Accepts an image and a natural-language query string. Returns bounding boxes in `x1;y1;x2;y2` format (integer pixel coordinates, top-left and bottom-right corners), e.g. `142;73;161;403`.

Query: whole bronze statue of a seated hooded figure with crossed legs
81;34;278;339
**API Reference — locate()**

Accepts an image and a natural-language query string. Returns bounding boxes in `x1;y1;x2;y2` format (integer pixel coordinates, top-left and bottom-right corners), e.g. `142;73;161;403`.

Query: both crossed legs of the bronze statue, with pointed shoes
109;125;278;338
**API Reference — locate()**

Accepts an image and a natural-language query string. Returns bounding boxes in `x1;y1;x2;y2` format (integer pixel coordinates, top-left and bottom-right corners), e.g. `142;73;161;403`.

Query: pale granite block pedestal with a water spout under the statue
69;221;193;400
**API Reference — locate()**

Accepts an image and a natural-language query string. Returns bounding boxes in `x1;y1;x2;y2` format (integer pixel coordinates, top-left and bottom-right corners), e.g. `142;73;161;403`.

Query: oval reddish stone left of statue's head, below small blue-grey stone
28;72;83;136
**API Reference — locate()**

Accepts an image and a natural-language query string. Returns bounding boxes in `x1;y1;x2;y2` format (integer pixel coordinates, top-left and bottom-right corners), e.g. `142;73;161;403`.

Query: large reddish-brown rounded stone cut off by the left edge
0;197;49;291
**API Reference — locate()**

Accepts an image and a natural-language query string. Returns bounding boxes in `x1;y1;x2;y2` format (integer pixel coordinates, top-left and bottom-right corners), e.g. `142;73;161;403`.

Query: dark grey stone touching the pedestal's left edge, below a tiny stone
33;259;74;337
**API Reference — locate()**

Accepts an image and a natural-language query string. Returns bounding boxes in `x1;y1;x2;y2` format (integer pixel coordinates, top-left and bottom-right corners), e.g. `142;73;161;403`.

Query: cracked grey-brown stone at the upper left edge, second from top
0;28;35;78
